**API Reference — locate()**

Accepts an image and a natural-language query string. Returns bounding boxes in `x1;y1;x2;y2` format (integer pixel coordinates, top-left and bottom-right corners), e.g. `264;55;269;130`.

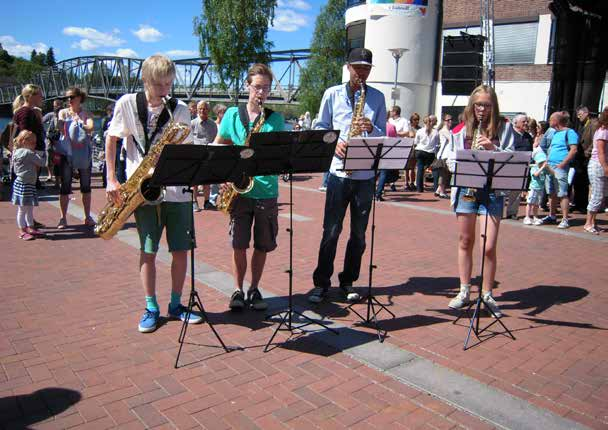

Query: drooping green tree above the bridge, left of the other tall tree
194;0;277;101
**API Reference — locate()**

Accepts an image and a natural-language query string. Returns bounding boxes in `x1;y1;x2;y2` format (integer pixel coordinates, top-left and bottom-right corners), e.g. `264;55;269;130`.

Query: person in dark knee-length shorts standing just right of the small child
55;87;95;230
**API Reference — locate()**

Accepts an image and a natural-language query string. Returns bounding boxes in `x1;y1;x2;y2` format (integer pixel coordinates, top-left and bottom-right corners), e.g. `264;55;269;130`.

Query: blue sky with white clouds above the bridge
0;0;326;61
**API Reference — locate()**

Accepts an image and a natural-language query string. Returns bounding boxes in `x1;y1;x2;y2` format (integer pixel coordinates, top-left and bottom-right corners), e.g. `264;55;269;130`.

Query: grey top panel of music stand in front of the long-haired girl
453;149;532;190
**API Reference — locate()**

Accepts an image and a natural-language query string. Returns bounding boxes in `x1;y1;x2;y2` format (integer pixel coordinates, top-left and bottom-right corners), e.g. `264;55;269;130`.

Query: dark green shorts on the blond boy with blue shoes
135;202;192;254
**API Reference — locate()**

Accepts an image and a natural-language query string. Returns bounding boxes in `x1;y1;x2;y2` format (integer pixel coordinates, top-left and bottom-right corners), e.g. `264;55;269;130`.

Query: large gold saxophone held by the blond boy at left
95;95;190;240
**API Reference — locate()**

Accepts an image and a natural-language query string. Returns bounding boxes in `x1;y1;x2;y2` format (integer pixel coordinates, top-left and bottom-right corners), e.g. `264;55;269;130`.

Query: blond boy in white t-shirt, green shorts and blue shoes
106;55;202;333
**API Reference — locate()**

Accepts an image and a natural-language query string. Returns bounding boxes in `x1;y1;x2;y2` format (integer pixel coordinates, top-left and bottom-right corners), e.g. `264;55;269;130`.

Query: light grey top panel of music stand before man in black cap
344;137;414;170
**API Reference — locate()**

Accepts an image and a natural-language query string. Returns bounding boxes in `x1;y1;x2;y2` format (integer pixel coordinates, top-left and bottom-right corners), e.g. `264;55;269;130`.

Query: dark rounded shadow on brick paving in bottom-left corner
0;387;82;428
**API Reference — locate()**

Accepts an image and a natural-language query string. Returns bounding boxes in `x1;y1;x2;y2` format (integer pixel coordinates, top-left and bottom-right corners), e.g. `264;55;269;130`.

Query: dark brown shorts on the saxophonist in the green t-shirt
230;196;279;252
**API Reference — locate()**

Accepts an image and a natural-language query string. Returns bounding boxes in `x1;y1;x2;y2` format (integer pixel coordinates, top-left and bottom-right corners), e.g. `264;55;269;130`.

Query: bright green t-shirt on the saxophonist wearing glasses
218;107;285;199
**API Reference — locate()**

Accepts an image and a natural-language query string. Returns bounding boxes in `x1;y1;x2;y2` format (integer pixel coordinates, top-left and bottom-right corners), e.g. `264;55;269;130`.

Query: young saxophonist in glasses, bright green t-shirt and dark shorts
215;64;285;310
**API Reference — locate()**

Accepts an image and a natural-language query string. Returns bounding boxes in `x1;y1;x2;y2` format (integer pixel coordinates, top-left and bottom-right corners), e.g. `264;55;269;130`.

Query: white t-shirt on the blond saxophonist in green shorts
108;94;192;202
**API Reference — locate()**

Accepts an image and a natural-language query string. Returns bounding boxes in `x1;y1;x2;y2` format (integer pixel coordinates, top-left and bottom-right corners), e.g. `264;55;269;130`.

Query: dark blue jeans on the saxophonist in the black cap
312;175;374;288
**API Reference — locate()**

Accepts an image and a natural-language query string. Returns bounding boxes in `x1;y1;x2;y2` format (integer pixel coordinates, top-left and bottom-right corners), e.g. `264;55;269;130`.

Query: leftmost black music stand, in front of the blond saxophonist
151;145;250;369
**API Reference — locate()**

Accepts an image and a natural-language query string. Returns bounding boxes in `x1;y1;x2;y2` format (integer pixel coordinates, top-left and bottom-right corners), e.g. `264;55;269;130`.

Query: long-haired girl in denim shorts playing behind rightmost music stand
448;85;513;318
